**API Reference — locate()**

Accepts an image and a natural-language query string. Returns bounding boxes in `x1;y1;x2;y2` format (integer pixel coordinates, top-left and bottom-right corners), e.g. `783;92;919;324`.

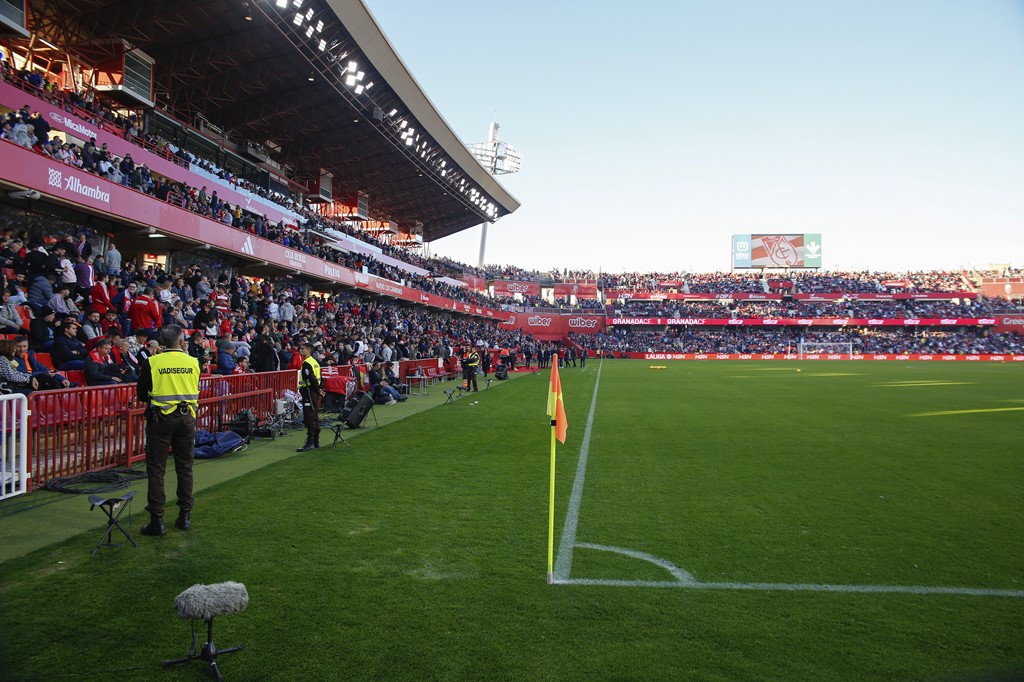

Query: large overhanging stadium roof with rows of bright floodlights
30;0;519;241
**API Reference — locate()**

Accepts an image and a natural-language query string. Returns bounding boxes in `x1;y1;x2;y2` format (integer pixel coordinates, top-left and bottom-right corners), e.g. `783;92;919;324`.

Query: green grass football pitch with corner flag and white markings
0;359;1024;681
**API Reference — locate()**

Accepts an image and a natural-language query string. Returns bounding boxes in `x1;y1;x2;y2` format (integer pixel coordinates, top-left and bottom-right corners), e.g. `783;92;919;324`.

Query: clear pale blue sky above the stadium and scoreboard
365;0;1024;271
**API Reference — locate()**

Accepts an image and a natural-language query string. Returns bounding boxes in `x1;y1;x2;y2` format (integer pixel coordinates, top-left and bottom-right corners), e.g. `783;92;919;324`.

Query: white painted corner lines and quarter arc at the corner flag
552;359;1024;599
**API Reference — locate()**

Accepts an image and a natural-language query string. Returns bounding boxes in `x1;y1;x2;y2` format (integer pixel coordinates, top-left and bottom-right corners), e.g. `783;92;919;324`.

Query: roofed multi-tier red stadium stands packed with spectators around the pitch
0;0;1024;484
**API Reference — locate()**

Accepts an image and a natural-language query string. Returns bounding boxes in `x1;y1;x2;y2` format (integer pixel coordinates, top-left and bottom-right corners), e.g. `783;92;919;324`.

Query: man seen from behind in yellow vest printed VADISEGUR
138;325;200;536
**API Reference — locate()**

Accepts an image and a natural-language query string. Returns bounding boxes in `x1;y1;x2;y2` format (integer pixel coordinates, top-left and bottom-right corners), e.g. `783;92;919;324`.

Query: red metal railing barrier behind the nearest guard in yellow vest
29;371;297;486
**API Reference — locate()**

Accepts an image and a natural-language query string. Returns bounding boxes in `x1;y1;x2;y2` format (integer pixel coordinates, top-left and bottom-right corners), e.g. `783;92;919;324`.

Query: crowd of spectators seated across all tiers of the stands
0;57;1022;390
